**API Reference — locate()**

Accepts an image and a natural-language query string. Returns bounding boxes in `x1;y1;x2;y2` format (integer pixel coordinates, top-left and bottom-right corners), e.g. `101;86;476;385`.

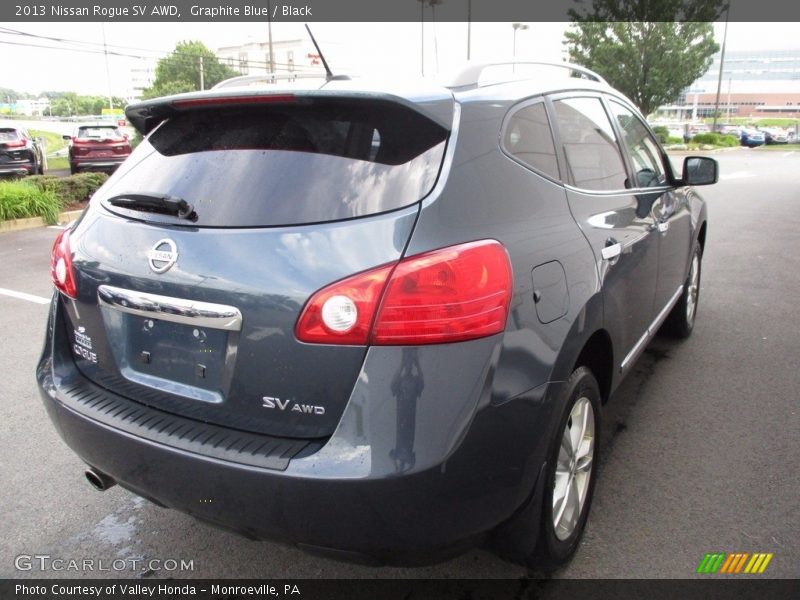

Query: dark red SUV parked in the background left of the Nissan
63;123;131;174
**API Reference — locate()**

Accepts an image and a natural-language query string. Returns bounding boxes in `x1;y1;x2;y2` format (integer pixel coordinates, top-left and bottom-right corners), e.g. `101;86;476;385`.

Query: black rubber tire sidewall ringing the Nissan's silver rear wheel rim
537;367;602;569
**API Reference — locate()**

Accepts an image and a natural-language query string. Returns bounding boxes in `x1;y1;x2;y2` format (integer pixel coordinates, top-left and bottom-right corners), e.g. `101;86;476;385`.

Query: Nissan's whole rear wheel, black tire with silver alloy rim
494;367;601;573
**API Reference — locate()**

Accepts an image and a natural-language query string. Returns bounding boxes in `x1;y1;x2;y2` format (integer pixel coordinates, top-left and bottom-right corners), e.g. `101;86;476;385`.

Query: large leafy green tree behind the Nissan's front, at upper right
564;0;724;116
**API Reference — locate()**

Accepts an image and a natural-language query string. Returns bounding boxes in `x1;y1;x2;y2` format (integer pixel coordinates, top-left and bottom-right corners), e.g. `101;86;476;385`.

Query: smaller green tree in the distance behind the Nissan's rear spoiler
144;42;238;98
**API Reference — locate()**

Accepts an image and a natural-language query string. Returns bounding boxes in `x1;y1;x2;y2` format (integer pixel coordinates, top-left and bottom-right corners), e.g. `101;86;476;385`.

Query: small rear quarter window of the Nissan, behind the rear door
503;102;560;180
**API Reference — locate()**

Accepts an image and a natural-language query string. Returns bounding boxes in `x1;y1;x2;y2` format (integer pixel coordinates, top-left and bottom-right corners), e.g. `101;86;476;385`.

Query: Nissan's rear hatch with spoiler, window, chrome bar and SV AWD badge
57;89;452;438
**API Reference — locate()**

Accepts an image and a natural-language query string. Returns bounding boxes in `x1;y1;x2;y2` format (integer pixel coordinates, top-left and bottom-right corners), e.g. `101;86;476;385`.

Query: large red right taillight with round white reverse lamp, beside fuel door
296;240;512;345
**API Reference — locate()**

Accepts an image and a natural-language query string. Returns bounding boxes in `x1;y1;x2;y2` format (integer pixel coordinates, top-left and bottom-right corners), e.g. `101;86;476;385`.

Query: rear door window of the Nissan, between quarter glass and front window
553;98;627;191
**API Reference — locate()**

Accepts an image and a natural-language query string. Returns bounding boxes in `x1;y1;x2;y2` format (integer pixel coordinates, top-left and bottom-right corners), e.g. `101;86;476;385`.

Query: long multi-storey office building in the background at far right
656;48;800;120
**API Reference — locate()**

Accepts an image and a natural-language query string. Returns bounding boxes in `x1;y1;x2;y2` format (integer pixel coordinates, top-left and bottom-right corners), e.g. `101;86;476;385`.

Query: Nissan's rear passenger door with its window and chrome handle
550;93;658;368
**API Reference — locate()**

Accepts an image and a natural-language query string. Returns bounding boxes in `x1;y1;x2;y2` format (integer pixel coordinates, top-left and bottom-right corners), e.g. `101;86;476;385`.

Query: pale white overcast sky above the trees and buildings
0;22;800;96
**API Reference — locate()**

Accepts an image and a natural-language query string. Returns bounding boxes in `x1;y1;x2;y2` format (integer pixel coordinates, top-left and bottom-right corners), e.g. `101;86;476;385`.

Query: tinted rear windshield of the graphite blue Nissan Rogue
102;99;447;227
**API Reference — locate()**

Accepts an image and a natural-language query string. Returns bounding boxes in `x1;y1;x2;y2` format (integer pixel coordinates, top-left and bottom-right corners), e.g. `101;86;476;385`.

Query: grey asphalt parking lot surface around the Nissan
0;148;800;579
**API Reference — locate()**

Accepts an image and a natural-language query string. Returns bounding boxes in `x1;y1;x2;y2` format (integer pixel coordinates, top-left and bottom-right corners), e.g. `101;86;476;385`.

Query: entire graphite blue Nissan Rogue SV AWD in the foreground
37;64;718;569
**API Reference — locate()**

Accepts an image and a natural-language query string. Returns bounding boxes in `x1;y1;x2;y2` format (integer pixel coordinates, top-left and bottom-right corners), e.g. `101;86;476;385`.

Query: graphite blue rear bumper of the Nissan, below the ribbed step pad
37;303;549;564
